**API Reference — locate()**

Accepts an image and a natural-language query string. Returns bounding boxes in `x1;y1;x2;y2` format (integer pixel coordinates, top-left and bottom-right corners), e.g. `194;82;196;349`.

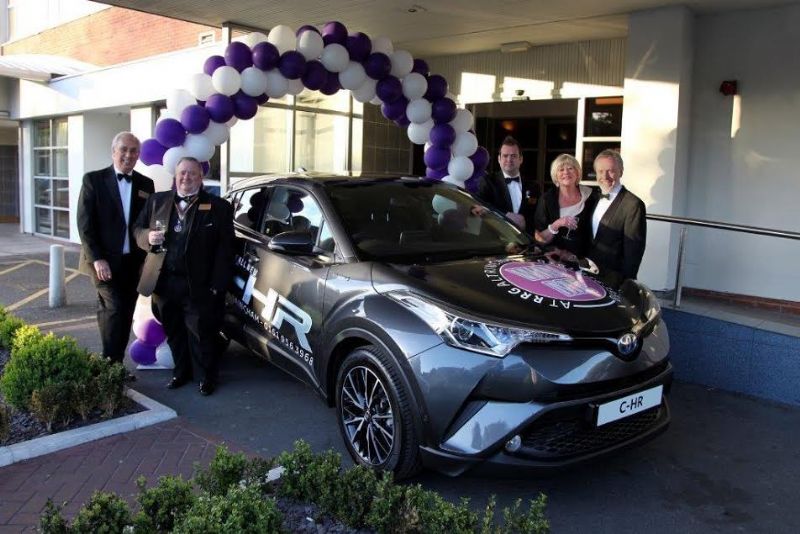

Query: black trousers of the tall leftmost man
95;257;140;363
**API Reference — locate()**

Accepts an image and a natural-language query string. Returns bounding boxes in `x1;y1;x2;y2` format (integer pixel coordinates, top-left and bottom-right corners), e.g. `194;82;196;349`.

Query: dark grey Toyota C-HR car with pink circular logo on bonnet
224;175;672;477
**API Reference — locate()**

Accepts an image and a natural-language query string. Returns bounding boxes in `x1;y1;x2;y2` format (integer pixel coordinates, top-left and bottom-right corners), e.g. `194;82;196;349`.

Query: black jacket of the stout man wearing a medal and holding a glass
134;189;233;307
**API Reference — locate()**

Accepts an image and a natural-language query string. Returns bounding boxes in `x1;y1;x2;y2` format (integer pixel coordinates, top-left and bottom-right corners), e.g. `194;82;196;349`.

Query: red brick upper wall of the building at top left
2;7;221;66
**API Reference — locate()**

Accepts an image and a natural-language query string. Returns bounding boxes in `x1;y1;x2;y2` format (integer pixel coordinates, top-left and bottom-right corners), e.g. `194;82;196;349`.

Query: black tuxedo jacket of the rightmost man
584;186;647;278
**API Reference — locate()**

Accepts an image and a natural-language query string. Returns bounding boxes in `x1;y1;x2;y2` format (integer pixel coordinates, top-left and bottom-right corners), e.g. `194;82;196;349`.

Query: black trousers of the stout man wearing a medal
153;272;218;382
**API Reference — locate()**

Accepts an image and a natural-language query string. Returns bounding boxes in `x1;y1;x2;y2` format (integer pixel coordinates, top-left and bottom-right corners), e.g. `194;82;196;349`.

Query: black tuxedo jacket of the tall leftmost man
78;165;154;281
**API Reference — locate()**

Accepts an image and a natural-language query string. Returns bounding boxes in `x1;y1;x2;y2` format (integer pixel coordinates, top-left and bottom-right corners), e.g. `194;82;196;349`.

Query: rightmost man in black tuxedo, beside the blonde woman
587;150;647;278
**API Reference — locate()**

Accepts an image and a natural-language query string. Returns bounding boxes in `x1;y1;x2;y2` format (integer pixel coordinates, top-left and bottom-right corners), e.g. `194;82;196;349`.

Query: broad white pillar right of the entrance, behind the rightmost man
622;7;694;289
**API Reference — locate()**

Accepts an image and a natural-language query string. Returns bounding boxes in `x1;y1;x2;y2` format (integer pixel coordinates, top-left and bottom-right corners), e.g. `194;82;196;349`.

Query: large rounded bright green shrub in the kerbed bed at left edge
0;327;89;409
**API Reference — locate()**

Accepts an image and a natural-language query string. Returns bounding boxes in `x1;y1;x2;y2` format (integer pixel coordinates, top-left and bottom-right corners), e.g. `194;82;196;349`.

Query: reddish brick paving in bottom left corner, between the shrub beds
0;418;241;534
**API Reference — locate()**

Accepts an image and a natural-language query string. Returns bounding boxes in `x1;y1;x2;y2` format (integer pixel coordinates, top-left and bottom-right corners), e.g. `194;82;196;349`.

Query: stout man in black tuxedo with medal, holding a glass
134;157;233;395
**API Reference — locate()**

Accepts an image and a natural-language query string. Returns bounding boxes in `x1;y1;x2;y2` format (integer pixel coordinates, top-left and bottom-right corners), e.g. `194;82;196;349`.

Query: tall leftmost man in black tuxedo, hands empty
78;132;154;370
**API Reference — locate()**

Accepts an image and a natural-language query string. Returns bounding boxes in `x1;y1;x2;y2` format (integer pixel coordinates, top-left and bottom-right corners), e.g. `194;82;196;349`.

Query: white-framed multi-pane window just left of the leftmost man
33;118;69;238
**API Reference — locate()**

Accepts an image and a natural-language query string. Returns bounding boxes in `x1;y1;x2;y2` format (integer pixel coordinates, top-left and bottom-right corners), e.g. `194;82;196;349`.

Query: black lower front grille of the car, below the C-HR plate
516;407;668;460
